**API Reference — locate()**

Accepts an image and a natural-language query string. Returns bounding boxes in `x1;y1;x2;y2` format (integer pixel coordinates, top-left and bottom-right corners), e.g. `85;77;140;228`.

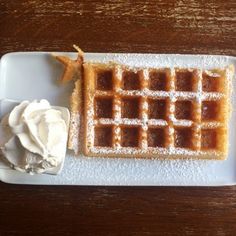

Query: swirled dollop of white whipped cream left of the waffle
1;99;70;174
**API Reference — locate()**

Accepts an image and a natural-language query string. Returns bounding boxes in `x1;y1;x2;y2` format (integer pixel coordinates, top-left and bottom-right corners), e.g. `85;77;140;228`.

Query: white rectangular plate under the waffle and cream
0;52;236;186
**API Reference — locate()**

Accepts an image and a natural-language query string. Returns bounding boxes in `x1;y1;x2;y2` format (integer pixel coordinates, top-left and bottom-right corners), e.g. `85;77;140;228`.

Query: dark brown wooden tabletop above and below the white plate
0;0;236;236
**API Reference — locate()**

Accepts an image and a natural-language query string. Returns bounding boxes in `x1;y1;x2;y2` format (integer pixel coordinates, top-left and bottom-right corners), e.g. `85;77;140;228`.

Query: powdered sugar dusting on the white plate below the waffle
42;153;225;185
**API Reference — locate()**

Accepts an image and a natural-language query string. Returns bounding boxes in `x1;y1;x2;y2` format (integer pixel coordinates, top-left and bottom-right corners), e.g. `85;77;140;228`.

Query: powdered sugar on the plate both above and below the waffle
48;54;236;185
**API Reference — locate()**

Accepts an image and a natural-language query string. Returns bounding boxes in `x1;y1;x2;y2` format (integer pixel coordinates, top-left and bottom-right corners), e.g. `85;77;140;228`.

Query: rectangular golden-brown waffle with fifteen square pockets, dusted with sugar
78;63;234;159
